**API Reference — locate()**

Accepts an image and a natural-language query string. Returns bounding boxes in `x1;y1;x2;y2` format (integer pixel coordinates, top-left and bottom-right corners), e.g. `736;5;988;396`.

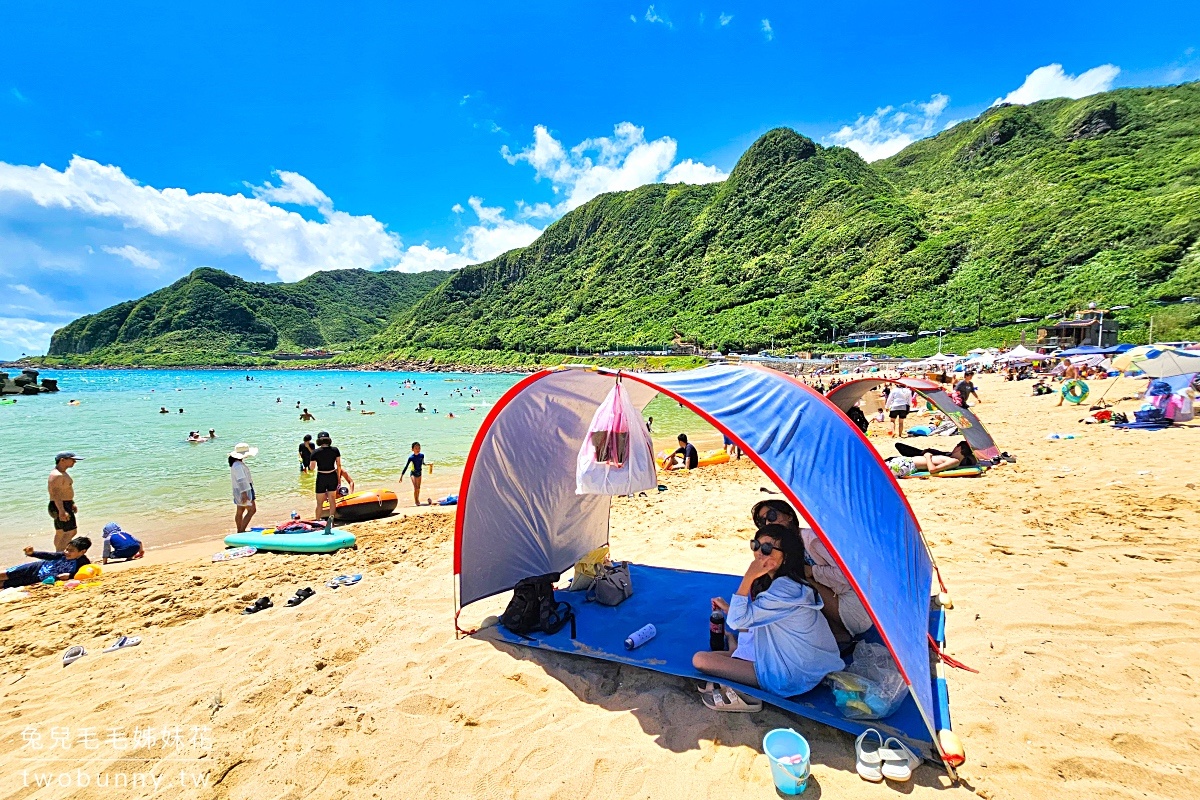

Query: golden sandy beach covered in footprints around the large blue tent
0;375;1200;800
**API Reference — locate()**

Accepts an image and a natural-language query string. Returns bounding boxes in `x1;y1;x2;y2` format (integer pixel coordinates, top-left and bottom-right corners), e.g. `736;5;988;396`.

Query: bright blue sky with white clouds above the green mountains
0;1;1200;357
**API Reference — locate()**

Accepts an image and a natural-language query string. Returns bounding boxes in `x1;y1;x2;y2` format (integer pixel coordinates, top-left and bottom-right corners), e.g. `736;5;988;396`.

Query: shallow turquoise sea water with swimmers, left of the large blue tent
0;369;707;554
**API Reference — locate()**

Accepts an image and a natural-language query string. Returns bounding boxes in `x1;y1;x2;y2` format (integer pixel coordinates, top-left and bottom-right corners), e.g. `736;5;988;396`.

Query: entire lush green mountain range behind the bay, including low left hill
44;83;1200;363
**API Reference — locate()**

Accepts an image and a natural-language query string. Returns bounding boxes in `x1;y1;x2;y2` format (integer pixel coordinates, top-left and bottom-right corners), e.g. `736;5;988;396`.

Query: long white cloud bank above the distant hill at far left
0;156;401;281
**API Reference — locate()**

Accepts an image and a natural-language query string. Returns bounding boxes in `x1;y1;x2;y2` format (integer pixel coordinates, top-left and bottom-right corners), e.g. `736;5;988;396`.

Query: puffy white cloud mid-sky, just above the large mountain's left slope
500;122;726;216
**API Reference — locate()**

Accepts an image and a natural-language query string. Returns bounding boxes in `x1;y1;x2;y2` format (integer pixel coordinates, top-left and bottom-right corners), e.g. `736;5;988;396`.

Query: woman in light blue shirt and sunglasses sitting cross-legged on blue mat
691;525;845;708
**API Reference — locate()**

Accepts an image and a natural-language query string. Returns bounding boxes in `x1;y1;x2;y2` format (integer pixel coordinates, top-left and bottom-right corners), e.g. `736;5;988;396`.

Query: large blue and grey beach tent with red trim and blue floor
454;365;949;772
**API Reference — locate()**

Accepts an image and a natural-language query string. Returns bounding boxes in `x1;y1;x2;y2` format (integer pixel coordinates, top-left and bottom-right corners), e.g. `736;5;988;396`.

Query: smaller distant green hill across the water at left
49;267;449;365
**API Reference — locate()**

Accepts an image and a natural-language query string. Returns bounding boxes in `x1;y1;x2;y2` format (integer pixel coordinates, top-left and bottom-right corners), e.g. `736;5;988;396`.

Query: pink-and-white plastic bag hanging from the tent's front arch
575;383;659;495
